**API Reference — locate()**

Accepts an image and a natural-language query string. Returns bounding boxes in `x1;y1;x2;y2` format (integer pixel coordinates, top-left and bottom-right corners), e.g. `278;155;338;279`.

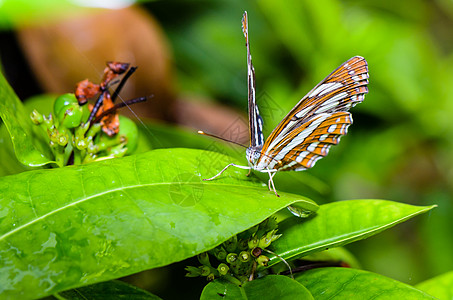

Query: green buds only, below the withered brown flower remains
30;94;138;167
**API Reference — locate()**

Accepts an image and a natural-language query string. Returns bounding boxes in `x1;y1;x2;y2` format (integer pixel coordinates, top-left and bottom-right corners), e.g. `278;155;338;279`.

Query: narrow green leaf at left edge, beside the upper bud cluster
0;74;52;166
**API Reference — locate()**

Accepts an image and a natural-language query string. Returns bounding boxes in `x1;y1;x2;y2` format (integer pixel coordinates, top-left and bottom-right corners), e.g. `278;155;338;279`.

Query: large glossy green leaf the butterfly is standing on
0;149;317;298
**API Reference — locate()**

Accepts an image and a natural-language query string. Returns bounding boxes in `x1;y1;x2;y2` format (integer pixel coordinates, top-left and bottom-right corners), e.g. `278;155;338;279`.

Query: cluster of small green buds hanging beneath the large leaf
186;217;281;284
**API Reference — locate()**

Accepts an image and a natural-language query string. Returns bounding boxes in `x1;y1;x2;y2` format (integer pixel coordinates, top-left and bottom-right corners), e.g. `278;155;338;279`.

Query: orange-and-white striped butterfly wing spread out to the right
256;56;369;171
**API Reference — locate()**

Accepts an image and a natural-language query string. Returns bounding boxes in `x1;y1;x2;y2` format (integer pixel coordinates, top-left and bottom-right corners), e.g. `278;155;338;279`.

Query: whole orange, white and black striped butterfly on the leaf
199;12;369;196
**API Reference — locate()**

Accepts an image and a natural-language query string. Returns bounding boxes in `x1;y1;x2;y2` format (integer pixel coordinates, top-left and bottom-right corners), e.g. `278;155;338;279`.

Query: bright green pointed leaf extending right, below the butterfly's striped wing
269;200;435;266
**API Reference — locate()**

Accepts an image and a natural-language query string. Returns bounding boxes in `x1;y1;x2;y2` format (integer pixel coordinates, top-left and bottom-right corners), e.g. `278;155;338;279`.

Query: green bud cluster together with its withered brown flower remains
30;62;147;167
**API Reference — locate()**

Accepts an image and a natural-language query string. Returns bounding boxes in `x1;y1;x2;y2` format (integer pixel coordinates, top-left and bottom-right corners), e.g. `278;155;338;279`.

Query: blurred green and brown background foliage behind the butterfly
0;0;453;296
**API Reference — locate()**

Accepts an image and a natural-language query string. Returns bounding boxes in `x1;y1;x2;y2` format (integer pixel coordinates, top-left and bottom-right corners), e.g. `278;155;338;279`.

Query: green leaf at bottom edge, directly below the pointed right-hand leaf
296;268;435;300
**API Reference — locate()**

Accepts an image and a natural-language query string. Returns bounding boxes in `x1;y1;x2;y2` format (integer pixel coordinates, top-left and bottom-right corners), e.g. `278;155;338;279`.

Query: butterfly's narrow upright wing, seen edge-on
242;12;264;148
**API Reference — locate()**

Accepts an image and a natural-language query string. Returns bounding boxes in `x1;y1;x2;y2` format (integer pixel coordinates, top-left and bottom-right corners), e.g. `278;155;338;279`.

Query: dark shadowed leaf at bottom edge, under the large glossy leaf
47;280;161;300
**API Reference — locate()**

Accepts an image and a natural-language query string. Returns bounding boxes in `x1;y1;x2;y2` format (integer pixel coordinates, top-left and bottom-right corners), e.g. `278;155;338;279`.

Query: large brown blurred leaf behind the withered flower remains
18;7;173;120
